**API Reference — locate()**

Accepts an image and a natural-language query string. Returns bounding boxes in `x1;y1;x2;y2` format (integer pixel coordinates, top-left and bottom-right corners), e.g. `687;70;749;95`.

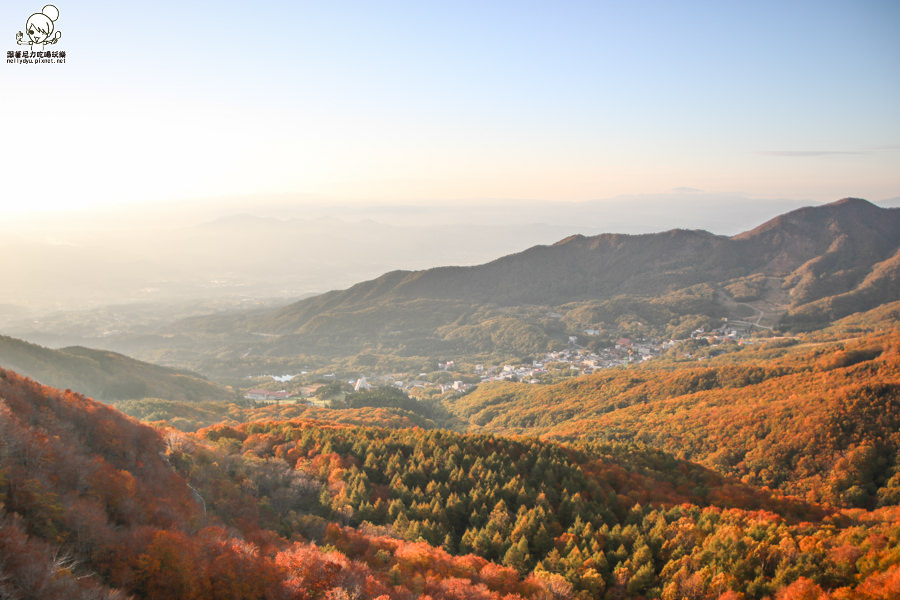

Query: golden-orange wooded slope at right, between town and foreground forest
450;308;900;508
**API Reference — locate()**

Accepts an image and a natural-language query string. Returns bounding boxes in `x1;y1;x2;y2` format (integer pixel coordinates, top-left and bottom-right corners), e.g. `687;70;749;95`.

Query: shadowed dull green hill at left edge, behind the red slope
0;336;234;402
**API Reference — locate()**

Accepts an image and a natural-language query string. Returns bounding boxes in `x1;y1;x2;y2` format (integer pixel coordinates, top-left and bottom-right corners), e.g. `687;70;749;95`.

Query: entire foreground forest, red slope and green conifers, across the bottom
0;360;900;600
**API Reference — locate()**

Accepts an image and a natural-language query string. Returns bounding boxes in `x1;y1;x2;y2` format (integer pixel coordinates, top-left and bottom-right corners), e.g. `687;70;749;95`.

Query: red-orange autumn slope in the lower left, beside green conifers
0;371;561;600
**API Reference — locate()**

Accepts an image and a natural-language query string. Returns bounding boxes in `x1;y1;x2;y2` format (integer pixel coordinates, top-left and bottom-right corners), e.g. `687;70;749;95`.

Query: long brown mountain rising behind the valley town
185;198;900;366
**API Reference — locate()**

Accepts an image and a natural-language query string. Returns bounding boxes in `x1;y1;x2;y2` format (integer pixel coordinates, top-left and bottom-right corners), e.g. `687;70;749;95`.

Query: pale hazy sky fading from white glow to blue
0;0;900;214
